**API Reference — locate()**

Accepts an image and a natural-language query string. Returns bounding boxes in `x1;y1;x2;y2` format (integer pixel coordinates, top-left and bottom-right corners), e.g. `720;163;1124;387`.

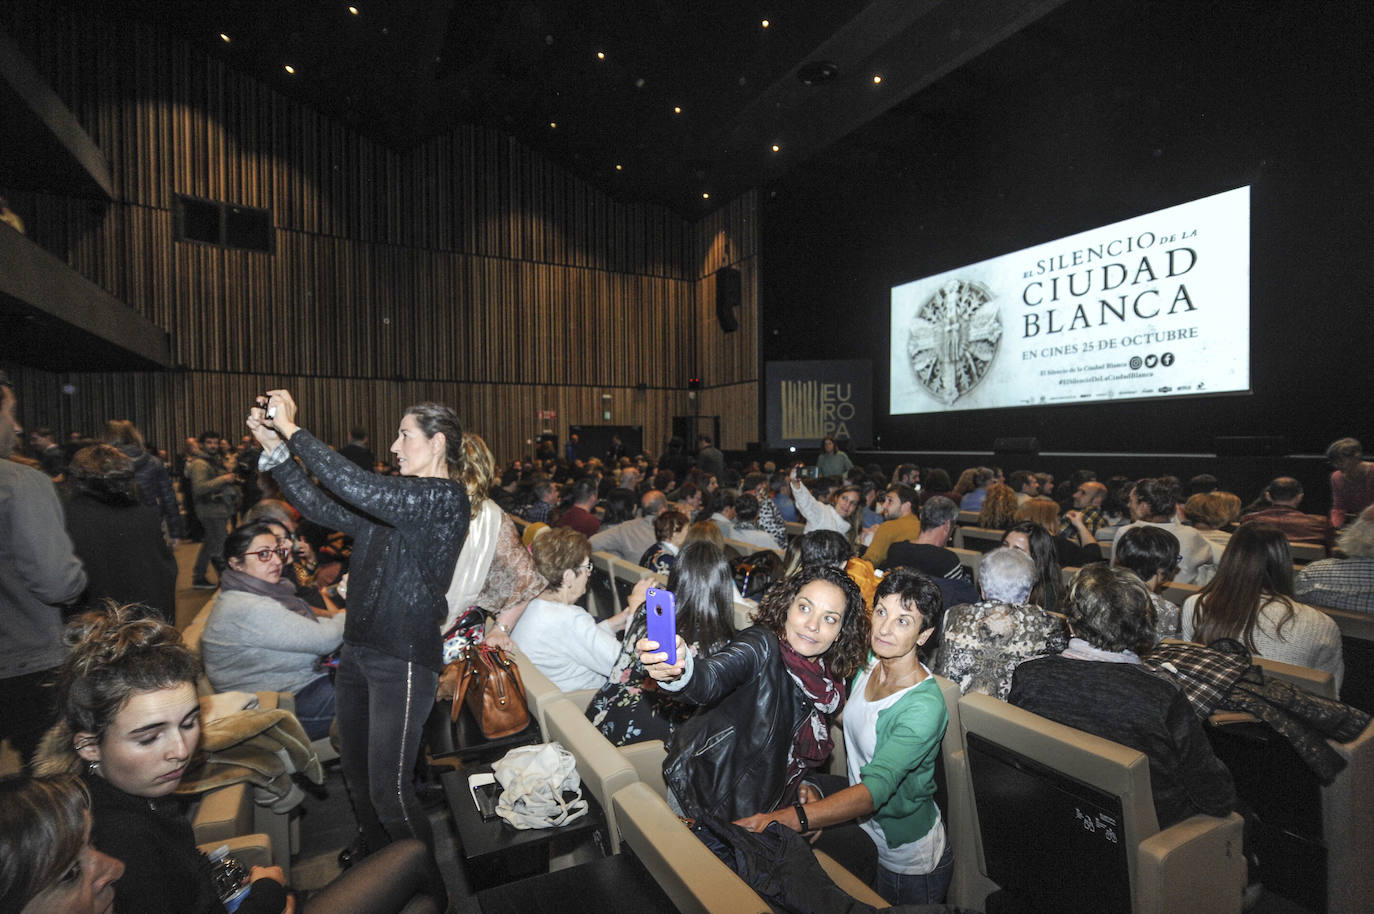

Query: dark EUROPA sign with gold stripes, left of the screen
767;359;872;448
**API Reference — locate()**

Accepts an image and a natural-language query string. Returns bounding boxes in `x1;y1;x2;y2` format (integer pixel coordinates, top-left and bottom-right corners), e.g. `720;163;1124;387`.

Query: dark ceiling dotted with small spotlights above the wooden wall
100;0;1063;216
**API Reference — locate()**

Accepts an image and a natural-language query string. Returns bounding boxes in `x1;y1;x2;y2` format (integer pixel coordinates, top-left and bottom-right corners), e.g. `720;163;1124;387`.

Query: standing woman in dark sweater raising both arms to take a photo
247;390;469;856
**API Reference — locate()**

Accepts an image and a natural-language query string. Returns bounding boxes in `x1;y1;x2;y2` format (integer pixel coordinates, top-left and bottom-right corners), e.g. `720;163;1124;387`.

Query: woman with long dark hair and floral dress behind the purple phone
587;541;735;746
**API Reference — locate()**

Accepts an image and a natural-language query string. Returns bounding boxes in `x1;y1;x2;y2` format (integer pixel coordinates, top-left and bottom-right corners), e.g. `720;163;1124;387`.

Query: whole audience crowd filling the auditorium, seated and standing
0;374;1374;911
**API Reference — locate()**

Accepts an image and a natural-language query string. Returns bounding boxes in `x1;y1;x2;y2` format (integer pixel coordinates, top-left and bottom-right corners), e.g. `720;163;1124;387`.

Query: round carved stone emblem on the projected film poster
907;279;1002;405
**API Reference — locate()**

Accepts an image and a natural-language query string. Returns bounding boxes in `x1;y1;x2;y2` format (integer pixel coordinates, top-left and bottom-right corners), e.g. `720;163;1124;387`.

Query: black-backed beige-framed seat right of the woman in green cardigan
956;693;1246;914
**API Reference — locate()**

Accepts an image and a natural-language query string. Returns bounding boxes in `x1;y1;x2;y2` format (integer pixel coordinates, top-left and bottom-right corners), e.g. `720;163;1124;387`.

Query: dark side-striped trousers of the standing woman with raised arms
334;643;438;852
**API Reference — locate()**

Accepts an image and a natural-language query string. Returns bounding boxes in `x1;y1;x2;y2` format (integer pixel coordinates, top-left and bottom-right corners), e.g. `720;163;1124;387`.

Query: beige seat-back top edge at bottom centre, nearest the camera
613;783;771;914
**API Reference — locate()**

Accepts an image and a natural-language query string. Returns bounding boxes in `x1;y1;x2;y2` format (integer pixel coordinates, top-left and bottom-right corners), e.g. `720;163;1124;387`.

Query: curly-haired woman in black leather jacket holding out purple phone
636;566;868;822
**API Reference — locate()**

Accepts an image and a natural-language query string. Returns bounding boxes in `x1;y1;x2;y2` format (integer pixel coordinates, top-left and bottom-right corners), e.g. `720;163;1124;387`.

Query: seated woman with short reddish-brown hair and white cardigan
511;526;632;691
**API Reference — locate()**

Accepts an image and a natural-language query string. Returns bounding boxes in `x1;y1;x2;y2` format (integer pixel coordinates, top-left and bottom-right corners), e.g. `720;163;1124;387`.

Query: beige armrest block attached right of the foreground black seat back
1135;812;1246;914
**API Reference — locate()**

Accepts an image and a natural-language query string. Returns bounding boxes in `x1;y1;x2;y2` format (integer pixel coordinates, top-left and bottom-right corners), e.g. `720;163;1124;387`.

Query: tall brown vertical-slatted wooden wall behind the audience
0;0;758;456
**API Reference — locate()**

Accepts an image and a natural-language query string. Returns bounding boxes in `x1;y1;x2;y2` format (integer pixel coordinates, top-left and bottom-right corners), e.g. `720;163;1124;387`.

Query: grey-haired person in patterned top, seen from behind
932;546;1069;700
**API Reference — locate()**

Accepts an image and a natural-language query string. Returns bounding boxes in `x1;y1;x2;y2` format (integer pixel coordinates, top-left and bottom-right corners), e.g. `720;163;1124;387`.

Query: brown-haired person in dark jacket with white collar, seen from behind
1007;562;1235;829
